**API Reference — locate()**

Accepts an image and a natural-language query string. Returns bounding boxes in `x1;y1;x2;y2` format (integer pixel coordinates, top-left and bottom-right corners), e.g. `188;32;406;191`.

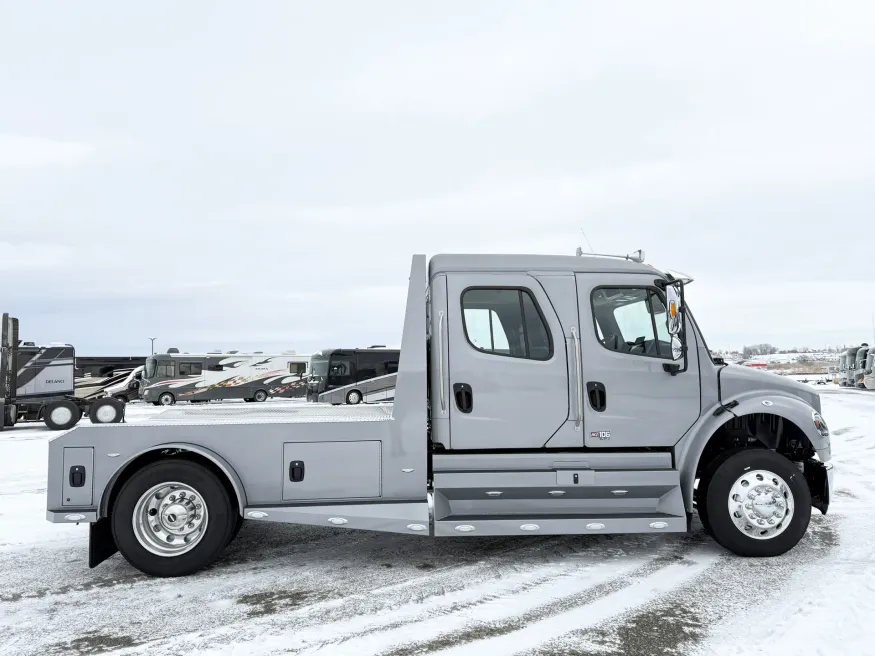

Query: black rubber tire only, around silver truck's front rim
700;449;811;557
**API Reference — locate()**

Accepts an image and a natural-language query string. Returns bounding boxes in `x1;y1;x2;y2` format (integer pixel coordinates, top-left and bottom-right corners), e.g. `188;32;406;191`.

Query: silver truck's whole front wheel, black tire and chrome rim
704;449;811;556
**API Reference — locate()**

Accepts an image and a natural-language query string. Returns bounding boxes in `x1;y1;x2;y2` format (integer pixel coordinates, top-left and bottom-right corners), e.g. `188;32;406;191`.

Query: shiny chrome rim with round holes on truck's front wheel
729;469;795;540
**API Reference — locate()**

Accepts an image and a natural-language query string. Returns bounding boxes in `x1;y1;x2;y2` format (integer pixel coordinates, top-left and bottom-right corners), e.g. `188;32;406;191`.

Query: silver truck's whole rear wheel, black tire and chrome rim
111;460;237;577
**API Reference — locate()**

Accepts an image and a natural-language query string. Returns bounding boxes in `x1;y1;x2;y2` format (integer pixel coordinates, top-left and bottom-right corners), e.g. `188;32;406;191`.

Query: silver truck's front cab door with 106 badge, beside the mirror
576;273;701;449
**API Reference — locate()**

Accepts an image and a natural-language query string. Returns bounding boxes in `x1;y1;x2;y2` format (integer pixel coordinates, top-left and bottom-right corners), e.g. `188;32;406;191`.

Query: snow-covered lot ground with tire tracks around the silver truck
0;386;875;656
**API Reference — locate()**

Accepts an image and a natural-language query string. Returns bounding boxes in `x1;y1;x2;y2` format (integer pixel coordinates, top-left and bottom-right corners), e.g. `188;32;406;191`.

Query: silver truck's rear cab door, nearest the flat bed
446;273;568;449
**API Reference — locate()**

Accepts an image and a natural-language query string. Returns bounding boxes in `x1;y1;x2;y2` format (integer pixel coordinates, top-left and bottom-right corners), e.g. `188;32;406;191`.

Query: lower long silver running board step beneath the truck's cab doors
434;513;687;536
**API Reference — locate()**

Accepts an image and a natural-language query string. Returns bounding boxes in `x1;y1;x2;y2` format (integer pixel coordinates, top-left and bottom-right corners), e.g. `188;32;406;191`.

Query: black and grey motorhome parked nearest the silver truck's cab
307;346;401;405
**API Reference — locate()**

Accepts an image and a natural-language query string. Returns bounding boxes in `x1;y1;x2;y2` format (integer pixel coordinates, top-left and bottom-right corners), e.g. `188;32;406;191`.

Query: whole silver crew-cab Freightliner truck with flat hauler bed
47;255;833;576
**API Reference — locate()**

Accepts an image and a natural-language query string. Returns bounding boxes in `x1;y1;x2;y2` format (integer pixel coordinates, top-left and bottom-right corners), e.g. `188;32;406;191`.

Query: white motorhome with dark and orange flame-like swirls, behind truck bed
142;349;310;405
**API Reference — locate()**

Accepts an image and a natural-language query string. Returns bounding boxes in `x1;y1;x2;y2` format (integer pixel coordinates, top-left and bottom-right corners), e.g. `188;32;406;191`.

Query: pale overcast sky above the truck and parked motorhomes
0;0;875;355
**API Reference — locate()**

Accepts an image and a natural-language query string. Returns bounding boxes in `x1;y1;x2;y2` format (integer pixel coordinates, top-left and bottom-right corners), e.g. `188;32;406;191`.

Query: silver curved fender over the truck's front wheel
675;392;832;512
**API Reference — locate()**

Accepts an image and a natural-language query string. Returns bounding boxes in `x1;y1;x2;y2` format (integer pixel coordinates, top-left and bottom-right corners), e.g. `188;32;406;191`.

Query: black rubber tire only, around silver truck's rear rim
110;460;237;577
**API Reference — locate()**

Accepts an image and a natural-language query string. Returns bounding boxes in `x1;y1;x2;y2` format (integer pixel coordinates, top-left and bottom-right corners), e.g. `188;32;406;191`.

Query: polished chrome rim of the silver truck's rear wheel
132;482;209;557
